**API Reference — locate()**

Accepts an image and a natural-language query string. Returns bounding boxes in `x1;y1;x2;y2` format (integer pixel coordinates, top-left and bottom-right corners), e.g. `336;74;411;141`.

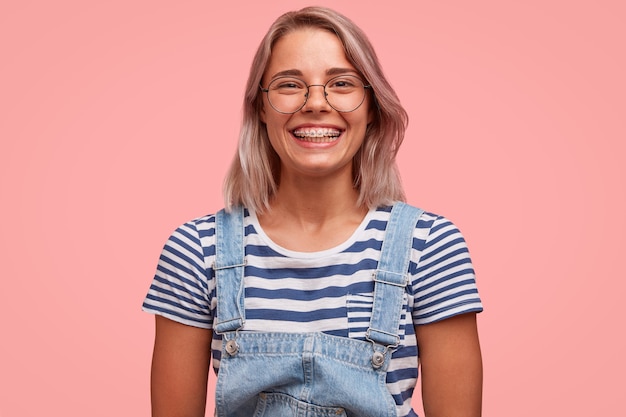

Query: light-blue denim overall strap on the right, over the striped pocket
366;202;424;347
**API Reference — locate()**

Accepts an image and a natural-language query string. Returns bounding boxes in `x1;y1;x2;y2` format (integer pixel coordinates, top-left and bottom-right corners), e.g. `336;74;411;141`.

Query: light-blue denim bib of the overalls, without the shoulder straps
216;332;396;417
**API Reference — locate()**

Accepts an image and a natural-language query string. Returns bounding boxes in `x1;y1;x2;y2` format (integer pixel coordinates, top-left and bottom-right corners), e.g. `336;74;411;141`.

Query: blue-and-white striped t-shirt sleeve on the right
410;214;483;325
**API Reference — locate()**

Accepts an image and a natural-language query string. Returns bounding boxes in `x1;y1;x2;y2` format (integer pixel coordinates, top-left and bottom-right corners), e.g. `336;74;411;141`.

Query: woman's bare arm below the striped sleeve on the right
415;313;483;417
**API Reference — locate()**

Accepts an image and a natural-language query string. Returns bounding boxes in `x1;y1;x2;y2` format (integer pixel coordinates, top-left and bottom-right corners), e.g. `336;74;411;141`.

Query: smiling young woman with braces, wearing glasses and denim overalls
144;7;482;417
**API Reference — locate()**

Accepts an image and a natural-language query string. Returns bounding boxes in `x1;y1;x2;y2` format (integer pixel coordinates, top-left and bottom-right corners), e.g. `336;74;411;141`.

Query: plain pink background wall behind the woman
0;0;626;417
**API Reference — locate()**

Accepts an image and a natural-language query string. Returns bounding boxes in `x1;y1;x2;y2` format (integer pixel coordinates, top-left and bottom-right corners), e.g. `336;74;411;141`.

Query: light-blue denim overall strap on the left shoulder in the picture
213;207;246;333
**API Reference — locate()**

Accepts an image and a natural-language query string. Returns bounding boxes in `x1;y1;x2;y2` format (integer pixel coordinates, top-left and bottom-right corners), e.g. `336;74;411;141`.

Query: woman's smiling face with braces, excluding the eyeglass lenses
261;28;372;180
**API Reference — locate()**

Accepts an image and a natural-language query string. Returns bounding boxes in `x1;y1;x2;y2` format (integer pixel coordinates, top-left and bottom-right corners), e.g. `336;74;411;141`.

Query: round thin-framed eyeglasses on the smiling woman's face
259;75;372;114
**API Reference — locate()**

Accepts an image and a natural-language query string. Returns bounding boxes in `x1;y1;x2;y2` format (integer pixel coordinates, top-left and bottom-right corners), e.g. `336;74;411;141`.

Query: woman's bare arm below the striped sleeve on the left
151;315;212;417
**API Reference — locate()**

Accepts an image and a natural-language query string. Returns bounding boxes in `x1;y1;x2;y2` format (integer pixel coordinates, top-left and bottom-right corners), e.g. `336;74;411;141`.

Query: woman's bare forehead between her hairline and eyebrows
264;28;355;79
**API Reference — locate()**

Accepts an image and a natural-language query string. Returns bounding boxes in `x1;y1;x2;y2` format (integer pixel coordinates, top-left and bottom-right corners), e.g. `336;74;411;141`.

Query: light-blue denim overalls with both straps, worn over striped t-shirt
213;203;422;417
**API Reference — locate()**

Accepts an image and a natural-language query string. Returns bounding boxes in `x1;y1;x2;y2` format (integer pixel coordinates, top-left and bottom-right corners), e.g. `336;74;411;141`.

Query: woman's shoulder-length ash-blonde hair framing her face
224;7;408;212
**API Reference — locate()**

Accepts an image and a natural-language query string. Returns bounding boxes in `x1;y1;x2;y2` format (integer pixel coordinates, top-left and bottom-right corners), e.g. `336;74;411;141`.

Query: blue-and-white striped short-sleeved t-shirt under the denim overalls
143;207;482;417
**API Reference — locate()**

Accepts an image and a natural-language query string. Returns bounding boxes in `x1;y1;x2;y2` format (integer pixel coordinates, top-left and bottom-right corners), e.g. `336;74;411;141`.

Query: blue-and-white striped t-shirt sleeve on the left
142;222;213;329
